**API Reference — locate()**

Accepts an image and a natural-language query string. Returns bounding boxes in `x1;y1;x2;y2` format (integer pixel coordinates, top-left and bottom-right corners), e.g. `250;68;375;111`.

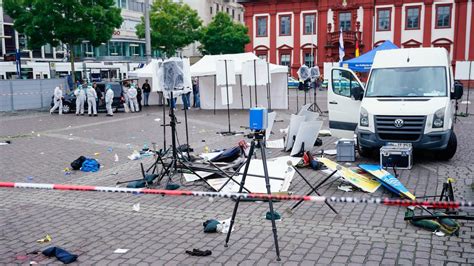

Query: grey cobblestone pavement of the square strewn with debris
0;93;474;265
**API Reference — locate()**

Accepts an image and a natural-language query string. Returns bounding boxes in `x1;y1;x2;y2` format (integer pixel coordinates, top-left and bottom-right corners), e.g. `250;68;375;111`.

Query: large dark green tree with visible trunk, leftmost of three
3;0;123;83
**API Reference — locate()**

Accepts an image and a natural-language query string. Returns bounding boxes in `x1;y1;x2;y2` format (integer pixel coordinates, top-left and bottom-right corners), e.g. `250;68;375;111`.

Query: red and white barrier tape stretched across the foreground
0;182;474;209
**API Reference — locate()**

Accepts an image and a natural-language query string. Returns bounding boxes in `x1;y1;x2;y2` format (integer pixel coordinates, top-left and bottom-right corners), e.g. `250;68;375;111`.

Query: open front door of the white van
328;67;364;138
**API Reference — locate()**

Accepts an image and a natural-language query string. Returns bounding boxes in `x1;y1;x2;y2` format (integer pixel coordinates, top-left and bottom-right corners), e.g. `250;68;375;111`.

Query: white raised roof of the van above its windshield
373;48;449;68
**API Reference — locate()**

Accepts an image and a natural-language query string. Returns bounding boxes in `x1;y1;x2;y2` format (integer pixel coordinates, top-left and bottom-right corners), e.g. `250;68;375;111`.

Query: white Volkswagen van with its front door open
328;48;462;160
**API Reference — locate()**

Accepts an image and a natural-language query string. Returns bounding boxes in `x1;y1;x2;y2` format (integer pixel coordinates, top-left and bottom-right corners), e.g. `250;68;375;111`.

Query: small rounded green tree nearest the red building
201;12;250;54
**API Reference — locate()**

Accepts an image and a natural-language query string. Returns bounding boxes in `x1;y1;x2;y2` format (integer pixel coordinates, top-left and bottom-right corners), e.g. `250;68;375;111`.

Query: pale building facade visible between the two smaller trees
175;0;244;59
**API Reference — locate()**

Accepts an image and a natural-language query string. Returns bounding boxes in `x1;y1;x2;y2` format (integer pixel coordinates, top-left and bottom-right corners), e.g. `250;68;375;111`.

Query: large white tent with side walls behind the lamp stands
191;53;288;109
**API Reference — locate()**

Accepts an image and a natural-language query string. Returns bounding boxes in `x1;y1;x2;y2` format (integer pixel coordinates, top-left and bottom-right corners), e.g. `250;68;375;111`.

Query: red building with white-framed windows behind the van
239;0;474;75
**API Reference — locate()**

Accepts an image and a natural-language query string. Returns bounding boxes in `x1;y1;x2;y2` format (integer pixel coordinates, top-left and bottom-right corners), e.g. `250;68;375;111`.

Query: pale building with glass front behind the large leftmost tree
0;0;152;62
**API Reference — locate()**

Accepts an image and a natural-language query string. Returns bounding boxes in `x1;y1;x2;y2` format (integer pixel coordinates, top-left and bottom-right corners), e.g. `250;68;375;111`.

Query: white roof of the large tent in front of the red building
191;53;288;77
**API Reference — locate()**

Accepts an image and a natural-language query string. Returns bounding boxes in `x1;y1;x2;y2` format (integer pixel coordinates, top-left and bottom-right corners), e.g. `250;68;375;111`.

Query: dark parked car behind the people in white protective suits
51;82;125;114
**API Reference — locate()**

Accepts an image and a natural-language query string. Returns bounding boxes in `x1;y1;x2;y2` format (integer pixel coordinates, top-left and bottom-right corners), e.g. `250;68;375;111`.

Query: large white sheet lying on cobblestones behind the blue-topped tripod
208;156;300;193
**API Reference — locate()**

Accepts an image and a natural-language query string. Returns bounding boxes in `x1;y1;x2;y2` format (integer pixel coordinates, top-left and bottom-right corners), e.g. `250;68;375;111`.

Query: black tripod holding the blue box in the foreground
224;130;281;261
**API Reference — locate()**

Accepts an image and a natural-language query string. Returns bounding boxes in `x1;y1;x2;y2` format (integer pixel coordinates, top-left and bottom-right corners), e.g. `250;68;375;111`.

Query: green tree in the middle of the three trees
137;0;202;56
